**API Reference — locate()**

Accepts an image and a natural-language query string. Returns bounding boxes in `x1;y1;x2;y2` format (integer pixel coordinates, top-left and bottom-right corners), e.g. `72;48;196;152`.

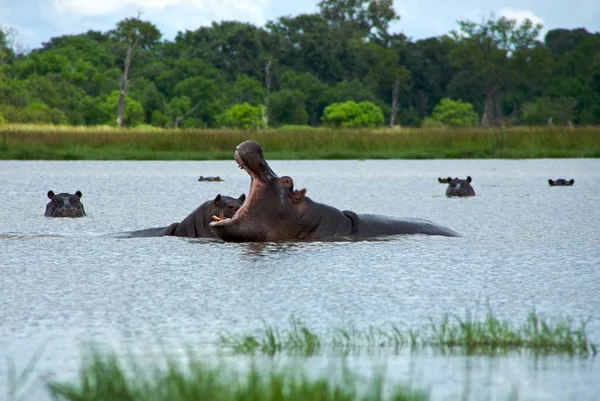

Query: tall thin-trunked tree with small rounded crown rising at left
109;14;162;127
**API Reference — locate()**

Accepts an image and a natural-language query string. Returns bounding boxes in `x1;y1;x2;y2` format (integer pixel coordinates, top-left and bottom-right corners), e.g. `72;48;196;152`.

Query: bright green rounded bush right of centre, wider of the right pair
323;101;383;128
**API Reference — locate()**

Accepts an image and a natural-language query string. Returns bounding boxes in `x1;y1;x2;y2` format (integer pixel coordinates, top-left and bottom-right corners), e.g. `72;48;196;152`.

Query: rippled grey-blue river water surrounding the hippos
0;159;600;400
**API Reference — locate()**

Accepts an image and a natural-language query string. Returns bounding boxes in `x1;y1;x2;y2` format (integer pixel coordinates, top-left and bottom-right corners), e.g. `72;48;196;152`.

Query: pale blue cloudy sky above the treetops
0;0;600;50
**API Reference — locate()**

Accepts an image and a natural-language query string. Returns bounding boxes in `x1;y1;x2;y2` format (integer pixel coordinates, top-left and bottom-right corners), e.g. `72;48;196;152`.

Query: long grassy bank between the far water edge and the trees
0;125;600;160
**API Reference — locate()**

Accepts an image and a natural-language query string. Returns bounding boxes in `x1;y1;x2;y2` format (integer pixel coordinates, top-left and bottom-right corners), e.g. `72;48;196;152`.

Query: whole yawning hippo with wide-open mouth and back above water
209;141;458;242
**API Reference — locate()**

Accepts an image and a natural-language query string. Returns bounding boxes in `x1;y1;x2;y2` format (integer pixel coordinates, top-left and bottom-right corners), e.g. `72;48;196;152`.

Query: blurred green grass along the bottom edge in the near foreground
47;347;429;401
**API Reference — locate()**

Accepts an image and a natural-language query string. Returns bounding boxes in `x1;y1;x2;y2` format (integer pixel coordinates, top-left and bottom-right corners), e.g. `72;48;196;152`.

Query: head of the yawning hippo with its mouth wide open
209;141;306;242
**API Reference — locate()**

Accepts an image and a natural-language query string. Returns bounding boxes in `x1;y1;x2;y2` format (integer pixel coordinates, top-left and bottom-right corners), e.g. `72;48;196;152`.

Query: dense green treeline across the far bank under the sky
0;0;600;128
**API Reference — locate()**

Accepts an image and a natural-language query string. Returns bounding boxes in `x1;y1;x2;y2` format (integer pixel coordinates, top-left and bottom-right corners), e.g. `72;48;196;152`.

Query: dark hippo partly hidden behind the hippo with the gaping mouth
126;194;246;238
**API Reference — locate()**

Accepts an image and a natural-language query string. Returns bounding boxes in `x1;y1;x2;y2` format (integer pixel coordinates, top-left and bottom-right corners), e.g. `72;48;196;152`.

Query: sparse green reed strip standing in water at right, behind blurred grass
220;311;597;356
